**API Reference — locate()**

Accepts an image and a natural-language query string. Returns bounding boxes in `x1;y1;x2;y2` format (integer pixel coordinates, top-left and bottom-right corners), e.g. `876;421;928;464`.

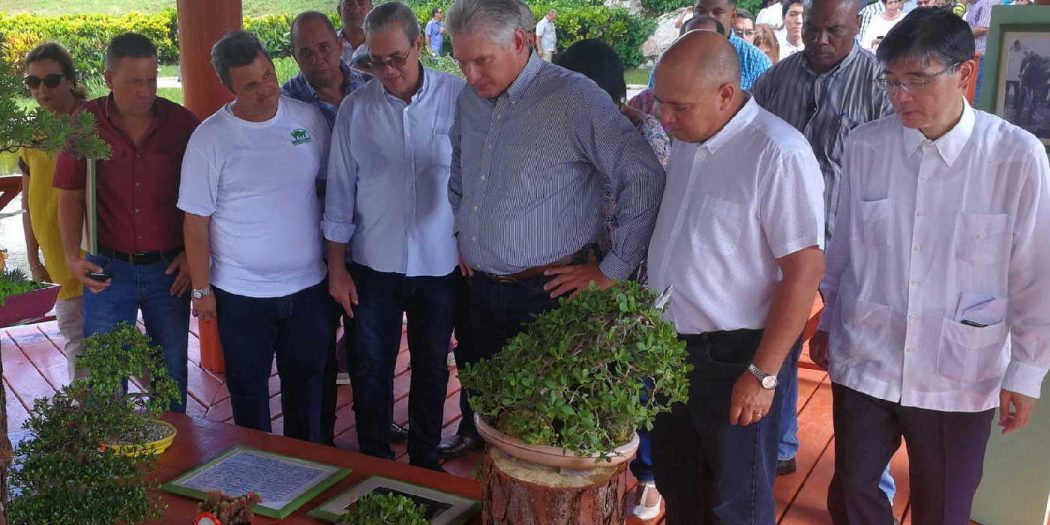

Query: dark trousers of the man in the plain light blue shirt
350;265;459;467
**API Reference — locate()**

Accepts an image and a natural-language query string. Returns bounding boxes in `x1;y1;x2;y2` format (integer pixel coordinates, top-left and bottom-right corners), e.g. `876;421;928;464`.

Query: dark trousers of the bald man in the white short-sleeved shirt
652;330;786;525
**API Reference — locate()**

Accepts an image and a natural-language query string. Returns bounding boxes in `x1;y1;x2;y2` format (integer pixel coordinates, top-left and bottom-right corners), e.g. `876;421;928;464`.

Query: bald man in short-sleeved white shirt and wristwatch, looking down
649;30;824;525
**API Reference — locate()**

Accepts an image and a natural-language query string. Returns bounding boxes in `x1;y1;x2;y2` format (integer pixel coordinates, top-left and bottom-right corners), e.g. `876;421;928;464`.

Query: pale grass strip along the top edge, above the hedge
0;0;337;17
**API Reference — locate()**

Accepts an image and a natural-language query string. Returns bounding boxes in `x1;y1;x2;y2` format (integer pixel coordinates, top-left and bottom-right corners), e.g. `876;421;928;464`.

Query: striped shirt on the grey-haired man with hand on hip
448;55;664;279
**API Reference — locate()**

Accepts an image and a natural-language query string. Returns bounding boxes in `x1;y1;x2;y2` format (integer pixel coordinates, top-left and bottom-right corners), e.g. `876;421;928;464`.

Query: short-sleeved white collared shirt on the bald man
649;99;824;334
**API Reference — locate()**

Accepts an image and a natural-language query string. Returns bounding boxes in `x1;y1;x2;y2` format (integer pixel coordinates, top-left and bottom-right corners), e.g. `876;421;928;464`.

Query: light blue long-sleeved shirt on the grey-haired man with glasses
322;68;463;277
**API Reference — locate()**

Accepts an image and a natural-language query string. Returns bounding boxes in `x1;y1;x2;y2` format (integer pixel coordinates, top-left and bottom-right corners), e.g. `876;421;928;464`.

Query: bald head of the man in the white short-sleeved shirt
653;30;744;143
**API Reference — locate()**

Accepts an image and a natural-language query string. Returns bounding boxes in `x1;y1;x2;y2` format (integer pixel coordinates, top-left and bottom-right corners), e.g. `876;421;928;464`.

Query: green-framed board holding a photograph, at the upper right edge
977;5;1050;151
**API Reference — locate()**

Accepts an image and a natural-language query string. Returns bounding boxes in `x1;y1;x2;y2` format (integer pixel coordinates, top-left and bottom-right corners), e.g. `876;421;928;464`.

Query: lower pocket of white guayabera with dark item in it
937;318;1008;383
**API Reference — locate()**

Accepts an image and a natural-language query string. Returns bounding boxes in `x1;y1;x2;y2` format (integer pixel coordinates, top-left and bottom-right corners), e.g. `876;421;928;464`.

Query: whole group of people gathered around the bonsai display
19;0;1050;525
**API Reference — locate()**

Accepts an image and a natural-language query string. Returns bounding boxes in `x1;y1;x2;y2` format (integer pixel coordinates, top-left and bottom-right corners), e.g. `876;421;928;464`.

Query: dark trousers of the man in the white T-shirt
215;280;333;443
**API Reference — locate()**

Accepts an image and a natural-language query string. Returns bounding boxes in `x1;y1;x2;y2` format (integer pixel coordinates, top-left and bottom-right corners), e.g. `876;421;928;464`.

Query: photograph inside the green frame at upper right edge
995;30;1050;146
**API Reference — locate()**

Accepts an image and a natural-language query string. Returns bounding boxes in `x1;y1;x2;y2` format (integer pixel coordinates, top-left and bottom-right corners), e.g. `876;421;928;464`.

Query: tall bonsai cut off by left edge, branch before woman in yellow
0;43;109;525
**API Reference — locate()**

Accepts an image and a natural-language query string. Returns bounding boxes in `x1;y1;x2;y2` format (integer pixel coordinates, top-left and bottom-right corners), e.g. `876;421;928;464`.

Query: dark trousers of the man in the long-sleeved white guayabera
827;383;995;525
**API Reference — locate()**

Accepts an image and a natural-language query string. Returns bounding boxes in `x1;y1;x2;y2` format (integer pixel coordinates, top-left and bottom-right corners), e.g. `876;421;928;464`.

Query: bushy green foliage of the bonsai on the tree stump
460;281;690;458
